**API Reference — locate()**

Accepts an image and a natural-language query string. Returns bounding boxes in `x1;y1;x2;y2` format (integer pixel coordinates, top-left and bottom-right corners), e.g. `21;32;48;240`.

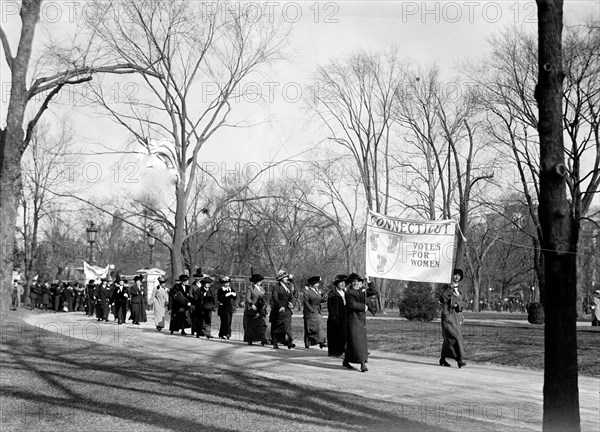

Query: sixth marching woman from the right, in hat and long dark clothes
244;274;268;345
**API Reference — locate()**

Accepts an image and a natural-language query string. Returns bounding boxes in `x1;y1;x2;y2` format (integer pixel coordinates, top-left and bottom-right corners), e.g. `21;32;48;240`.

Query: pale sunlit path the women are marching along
21;313;600;431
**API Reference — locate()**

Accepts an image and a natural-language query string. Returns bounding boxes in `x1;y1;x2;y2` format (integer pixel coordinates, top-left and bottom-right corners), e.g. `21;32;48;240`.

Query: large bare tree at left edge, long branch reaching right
0;0;155;314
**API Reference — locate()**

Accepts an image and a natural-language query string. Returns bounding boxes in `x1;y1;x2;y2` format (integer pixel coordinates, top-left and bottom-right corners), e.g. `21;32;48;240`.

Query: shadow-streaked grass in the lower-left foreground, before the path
0;318;445;432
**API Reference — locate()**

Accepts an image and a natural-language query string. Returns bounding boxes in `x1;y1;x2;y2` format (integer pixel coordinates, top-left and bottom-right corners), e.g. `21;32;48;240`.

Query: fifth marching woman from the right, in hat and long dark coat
269;271;296;349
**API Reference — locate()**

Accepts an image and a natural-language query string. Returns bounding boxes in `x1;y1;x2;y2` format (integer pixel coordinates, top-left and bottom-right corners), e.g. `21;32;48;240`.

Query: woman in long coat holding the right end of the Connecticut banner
440;269;467;368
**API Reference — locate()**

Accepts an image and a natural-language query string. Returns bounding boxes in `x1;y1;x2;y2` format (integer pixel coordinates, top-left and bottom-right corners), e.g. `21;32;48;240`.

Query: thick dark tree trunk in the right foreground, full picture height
535;0;581;431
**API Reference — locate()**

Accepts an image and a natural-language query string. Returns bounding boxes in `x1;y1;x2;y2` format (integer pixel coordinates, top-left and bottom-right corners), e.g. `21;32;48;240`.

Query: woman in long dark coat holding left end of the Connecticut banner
342;273;377;372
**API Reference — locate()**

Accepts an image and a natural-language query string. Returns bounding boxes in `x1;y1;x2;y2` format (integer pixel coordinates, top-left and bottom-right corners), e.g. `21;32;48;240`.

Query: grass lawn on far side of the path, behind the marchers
227;312;600;377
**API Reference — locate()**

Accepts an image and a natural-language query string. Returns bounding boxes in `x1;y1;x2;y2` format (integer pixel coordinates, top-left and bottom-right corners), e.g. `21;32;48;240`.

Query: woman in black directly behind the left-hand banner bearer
327;275;346;357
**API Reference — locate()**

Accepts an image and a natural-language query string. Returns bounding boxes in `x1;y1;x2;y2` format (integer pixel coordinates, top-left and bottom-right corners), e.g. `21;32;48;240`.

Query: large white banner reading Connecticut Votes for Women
365;210;456;283
